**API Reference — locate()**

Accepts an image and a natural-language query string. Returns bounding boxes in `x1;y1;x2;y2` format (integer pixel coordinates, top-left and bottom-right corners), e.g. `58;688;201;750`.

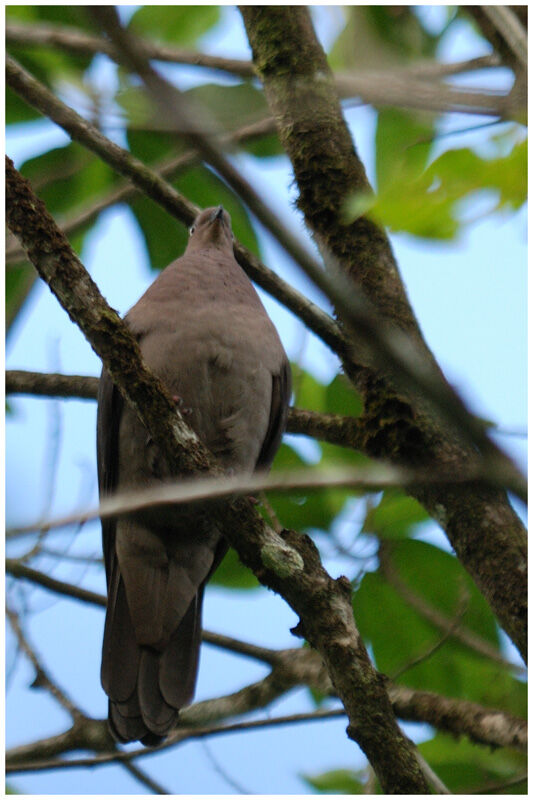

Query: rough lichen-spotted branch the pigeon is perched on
6;155;427;793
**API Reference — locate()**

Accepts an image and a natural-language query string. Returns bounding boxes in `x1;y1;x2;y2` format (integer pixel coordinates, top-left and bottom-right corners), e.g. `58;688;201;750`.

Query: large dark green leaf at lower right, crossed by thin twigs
353;539;524;700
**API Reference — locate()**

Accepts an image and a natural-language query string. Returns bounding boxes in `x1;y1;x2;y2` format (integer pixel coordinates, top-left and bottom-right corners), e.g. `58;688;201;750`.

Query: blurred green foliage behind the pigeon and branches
6;5;527;794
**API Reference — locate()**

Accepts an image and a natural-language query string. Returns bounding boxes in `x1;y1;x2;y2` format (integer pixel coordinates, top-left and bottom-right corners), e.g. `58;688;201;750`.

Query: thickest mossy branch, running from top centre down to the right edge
241;6;527;658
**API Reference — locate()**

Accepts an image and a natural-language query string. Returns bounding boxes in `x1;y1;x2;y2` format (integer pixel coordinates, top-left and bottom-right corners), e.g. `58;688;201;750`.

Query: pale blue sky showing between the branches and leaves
6;9;527;794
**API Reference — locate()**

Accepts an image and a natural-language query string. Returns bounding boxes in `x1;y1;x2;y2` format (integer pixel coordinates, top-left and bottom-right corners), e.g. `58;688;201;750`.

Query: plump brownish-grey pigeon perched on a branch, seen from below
97;206;291;746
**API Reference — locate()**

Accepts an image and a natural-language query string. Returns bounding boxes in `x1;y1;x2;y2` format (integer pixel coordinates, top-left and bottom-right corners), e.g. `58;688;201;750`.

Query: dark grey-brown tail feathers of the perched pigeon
101;569;204;746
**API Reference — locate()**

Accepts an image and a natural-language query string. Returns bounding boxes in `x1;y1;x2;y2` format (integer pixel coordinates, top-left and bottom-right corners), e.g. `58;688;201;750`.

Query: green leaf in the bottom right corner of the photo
418;733;527;795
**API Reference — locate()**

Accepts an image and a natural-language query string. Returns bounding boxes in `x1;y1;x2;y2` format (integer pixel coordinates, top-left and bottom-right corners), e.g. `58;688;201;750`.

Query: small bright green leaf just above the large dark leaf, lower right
362;490;430;539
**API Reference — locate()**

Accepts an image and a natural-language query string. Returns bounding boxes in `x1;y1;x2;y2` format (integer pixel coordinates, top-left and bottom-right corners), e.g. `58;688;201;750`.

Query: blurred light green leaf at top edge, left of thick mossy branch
129;5;220;45
